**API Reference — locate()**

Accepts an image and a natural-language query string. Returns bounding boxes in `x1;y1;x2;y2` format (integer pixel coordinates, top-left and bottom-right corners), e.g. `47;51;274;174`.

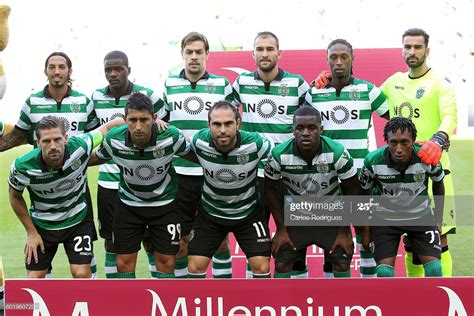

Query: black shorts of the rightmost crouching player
370;226;441;261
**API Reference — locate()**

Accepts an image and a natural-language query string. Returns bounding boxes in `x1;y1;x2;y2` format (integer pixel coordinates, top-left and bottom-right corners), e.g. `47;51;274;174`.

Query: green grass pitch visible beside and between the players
0;140;474;278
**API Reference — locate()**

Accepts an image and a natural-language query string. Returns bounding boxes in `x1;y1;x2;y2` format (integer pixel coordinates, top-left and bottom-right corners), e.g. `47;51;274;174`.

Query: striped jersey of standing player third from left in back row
163;70;233;176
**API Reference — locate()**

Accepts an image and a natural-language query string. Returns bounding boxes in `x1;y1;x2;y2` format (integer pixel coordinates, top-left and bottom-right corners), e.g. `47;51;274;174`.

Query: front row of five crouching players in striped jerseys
9;93;443;278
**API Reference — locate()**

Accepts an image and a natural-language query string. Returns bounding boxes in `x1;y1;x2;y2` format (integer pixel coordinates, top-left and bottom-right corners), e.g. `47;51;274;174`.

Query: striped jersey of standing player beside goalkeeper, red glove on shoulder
306;78;388;170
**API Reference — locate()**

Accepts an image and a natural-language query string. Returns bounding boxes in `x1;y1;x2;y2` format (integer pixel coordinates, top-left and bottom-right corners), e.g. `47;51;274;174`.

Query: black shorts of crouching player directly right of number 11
275;226;352;265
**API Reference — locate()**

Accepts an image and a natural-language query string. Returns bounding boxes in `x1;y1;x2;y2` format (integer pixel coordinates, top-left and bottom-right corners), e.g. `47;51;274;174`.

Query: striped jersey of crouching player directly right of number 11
265;136;357;196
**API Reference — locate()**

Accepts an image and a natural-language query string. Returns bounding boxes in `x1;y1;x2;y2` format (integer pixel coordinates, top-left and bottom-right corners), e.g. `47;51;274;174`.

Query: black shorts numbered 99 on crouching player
112;198;181;255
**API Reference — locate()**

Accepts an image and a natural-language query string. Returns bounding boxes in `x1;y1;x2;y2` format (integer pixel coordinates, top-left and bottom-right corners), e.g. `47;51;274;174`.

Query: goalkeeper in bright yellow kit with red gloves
314;29;457;276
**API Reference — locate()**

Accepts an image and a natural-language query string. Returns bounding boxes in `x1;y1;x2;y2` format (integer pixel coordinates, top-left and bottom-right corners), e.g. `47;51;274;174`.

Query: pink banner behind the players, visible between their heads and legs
207;48;406;278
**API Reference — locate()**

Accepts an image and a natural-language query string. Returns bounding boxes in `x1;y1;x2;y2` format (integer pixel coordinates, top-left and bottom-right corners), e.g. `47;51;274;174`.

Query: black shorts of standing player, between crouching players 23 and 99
97;185;118;241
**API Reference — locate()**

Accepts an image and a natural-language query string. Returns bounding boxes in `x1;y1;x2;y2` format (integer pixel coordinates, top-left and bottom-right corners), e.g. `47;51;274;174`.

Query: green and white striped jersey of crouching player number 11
191;129;271;220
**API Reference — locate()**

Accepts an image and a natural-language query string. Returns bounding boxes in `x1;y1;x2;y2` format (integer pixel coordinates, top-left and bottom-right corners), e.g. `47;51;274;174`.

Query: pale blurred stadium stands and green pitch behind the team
0;0;474;278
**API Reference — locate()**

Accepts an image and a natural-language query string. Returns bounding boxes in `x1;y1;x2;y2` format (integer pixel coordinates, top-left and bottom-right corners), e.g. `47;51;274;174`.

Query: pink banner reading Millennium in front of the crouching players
5;278;474;316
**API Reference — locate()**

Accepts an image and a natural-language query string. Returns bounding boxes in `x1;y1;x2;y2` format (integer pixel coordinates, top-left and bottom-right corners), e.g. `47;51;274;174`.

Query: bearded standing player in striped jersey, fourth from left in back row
233;32;309;277
